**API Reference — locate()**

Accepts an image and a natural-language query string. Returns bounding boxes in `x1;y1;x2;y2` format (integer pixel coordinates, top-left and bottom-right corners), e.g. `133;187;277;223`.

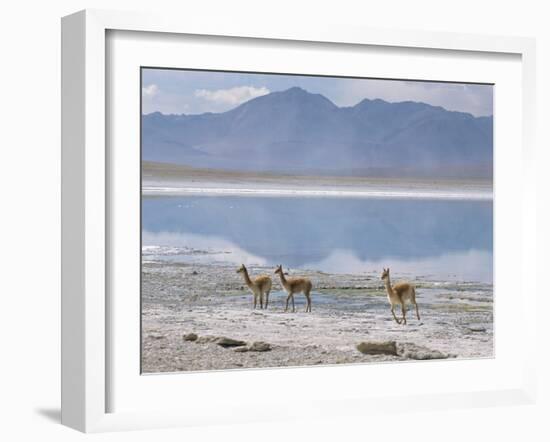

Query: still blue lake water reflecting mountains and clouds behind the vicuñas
142;195;493;282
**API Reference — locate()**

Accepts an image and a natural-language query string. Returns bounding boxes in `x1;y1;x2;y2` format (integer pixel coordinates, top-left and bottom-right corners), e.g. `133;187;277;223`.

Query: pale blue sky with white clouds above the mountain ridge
142;69;493;116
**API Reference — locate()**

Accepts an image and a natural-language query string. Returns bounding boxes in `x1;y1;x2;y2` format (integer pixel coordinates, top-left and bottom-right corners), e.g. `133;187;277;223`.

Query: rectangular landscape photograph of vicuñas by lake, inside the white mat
140;67;495;374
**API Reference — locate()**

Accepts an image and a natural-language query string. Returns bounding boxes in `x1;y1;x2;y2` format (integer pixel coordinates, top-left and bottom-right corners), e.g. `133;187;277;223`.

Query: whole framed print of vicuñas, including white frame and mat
62;11;535;431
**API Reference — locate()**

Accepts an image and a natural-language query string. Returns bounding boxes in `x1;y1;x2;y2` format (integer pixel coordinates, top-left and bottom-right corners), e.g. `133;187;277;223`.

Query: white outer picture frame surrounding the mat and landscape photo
62;10;536;432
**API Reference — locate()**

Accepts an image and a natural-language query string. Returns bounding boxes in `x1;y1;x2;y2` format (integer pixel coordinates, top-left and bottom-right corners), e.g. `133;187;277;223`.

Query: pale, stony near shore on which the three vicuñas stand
142;262;493;373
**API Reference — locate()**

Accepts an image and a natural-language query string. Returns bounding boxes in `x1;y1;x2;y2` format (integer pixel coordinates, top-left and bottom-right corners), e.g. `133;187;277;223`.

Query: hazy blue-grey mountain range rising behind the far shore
142;87;493;178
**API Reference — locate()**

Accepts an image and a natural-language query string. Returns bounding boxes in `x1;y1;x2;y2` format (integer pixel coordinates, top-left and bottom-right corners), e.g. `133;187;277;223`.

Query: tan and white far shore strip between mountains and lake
142;163;493;200
